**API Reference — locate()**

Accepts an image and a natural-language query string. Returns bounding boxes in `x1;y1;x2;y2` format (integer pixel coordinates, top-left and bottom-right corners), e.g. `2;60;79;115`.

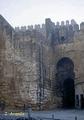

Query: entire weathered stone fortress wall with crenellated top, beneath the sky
0;16;84;109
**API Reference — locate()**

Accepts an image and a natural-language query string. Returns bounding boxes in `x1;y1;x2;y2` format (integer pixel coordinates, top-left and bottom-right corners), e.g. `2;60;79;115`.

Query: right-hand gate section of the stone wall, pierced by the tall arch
46;19;84;108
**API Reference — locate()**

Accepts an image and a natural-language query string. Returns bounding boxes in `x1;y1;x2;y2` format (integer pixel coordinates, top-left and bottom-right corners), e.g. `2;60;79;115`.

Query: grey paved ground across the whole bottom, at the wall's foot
0;110;84;120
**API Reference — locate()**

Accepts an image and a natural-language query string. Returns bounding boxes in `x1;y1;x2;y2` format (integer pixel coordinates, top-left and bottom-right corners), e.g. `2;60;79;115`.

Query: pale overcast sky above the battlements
0;0;84;27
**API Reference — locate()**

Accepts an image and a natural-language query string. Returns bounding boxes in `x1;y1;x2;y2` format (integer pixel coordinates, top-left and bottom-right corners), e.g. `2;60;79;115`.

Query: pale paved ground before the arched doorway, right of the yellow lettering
28;110;84;120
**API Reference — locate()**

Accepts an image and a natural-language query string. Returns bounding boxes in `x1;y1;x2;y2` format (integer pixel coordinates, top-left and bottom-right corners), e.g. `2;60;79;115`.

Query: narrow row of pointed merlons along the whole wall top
15;18;84;32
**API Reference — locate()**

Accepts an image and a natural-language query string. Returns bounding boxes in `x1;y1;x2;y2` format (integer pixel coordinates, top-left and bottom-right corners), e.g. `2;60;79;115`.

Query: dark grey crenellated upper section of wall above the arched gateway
45;18;84;44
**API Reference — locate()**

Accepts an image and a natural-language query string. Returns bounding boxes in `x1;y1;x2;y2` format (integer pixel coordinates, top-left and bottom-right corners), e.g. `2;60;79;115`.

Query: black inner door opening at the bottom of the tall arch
63;78;75;108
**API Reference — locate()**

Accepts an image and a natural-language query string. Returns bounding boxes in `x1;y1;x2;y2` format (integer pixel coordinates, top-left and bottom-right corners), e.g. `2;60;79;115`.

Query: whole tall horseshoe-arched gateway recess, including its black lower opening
56;57;75;108
